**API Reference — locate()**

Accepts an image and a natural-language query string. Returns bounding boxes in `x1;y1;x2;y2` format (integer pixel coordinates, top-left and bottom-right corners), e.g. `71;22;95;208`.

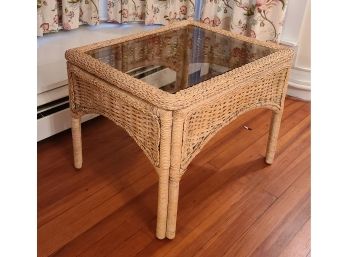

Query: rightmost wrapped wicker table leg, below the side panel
266;111;283;164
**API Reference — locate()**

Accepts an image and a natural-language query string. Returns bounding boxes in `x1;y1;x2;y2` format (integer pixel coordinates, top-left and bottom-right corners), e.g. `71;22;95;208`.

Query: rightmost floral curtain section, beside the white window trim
201;0;287;42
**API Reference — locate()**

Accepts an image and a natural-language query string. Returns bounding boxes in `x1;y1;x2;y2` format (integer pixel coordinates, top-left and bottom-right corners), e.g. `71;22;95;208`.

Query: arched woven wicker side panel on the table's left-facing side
69;63;160;167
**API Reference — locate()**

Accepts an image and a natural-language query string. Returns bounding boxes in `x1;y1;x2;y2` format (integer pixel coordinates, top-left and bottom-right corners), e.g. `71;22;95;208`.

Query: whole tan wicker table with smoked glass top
66;21;293;239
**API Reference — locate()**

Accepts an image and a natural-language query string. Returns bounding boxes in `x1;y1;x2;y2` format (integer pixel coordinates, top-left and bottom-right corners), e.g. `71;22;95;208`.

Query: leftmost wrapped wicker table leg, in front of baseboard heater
71;117;82;169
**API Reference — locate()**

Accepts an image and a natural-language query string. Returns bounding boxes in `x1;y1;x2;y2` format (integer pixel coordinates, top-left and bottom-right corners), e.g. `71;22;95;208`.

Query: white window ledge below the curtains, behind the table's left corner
37;23;159;94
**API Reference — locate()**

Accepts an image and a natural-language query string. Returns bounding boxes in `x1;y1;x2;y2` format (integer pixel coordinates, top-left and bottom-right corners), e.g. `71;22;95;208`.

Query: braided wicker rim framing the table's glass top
66;21;293;110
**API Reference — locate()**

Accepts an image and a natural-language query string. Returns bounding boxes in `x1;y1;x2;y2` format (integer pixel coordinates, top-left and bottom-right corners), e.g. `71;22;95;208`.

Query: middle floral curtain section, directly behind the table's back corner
108;0;195;24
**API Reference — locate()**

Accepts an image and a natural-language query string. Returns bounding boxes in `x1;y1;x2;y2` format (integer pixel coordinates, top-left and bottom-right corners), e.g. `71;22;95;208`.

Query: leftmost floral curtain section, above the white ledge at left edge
37;0;99;36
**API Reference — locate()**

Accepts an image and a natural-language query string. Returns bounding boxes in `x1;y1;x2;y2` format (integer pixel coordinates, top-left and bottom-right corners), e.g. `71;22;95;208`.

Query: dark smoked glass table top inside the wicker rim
87;25;275;93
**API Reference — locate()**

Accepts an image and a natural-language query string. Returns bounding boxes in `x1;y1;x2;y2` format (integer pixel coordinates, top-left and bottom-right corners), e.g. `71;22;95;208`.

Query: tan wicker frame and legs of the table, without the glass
66;21;293;239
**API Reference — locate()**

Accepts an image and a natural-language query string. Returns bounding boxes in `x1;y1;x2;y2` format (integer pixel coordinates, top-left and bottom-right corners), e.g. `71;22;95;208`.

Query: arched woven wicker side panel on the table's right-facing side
181;69;288;170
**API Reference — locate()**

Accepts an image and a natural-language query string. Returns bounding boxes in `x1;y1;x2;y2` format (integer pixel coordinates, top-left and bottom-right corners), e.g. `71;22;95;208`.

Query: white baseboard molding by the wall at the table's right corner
287;67;311;101
